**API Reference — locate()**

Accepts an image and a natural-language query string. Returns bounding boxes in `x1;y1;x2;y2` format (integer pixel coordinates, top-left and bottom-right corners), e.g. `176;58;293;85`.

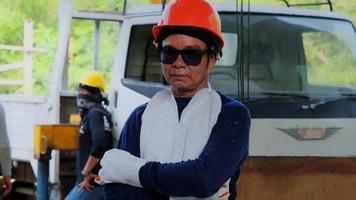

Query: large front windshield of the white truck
210;14;356;100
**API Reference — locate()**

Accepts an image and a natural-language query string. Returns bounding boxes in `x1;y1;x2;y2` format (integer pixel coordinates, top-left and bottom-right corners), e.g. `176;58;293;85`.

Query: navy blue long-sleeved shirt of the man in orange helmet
104;94;250;200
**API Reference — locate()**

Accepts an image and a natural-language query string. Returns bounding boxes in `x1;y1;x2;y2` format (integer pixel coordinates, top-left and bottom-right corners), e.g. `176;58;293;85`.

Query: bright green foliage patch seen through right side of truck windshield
303;27;356;93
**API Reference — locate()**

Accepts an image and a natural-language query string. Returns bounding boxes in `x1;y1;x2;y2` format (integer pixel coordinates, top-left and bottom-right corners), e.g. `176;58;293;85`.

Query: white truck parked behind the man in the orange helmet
0;0;356;200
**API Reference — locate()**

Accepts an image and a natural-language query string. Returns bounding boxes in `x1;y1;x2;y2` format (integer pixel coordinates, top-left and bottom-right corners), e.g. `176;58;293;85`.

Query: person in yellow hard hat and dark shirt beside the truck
65;71;113;200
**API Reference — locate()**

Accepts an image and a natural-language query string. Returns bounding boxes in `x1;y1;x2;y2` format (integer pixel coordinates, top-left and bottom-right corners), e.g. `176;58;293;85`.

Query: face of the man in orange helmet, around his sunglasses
162;34;216;97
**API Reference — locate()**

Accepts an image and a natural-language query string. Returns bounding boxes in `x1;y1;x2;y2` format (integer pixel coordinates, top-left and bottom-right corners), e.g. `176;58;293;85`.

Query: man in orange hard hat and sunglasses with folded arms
98;0;250;200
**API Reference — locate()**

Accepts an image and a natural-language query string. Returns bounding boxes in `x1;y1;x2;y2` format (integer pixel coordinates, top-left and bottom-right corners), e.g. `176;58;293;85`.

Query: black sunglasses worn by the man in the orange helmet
158;46;212;66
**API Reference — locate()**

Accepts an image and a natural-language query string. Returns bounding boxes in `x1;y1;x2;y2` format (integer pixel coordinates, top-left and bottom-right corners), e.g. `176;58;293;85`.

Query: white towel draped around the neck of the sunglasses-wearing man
140;88;221;200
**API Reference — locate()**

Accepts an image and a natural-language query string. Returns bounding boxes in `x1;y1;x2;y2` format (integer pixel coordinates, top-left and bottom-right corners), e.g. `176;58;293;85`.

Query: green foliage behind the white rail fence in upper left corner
0;0;58;95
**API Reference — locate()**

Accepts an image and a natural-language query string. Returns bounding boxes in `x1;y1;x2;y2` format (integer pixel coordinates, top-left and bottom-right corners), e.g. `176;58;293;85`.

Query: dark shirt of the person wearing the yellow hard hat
76;105;113;182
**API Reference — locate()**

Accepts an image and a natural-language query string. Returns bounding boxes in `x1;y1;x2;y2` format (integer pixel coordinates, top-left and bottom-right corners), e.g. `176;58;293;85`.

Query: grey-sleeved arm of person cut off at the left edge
0;103;12;200
